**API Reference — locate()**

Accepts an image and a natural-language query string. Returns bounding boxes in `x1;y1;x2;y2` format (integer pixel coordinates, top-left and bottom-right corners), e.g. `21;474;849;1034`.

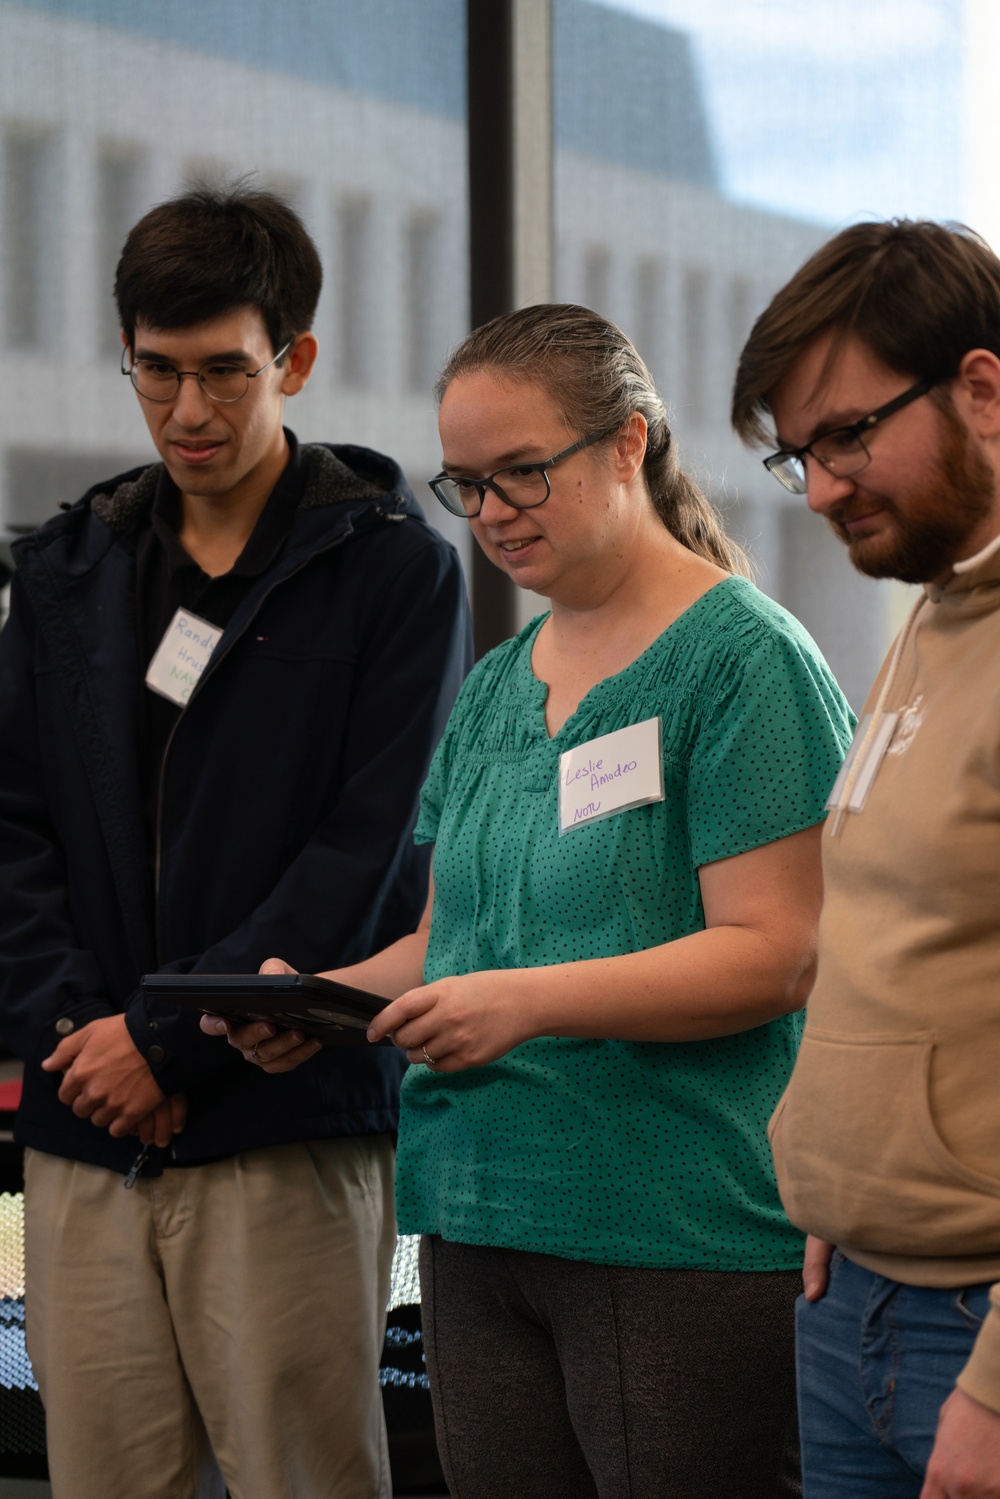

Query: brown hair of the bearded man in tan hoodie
732;219;1000;442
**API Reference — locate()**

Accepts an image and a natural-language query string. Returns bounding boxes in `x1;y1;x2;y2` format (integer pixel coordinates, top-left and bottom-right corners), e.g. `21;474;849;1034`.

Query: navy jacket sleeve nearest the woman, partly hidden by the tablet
126;540;472;1093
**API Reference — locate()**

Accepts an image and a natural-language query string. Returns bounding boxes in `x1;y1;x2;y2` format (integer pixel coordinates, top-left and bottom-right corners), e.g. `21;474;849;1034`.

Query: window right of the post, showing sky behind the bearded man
553;0;959;708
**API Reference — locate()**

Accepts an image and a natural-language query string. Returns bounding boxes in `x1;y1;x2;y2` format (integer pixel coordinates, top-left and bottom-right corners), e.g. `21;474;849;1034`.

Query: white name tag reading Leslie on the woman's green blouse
559;718;663;833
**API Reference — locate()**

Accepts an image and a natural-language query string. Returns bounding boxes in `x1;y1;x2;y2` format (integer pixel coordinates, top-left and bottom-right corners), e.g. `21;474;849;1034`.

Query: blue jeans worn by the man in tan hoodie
796;1250;990;1499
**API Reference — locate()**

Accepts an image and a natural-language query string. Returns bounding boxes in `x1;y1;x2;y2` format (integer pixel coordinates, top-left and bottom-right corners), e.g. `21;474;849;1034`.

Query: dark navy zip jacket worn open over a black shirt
0;445;471;1174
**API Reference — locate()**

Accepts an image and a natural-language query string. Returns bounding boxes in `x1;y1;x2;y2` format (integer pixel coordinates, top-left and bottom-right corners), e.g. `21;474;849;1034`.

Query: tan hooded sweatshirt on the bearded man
771;537;1000;1412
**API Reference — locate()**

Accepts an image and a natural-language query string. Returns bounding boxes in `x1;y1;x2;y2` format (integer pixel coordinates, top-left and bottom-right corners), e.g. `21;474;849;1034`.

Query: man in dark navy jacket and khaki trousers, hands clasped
0;187;469;1499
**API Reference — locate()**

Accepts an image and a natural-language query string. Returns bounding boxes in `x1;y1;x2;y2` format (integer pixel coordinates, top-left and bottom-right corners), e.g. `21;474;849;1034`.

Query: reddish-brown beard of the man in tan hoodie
829;408;997;583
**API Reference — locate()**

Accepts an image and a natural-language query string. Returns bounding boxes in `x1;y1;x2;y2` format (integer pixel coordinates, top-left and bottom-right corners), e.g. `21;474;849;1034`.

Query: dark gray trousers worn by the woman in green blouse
420;1237;802;1499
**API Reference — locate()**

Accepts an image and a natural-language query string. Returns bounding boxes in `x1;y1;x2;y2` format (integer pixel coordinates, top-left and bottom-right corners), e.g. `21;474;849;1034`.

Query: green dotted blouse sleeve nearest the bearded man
688;630;855;866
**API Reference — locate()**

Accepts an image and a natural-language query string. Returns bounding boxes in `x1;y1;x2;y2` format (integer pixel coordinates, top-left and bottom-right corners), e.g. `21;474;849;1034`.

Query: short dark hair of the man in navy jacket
114;181;322;352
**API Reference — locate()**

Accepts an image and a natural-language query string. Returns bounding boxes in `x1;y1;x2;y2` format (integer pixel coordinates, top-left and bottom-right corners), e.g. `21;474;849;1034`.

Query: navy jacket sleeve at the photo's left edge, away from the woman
0;576;117;1063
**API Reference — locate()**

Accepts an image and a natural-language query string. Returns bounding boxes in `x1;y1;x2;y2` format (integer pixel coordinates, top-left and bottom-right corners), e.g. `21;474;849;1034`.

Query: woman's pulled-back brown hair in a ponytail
436;303;751;577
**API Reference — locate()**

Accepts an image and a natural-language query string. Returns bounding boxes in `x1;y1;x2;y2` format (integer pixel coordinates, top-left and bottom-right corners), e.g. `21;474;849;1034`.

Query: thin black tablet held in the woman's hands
141;973;393;1046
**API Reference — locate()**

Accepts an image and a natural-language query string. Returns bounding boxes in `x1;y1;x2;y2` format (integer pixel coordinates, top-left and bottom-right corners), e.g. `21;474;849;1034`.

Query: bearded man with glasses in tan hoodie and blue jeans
733;220;1000;1499
